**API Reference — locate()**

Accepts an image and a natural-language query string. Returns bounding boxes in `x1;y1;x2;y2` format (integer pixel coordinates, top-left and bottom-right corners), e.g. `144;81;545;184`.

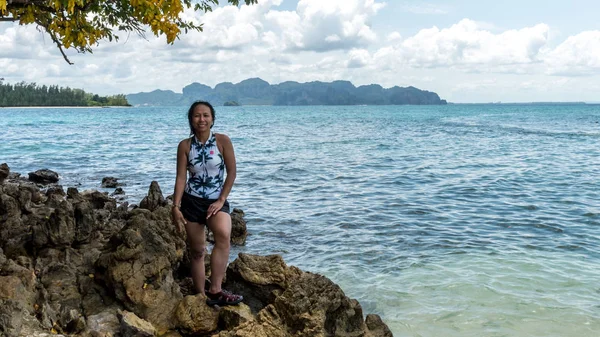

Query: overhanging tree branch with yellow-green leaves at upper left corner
0;0;258;64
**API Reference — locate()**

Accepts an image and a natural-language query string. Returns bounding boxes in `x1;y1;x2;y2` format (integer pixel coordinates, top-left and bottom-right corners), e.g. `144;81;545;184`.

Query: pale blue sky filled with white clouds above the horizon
0;0;600;102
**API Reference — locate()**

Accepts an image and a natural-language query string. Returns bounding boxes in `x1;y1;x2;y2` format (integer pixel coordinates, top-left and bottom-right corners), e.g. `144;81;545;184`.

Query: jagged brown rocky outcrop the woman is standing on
0;164;392;337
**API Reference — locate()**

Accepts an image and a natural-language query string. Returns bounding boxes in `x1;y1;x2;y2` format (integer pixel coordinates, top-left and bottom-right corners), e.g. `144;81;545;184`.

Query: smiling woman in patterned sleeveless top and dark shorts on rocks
173;101;243;305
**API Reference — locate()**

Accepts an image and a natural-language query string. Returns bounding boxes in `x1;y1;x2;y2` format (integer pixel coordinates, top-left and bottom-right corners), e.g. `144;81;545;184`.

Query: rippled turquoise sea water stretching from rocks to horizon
0;105;600;337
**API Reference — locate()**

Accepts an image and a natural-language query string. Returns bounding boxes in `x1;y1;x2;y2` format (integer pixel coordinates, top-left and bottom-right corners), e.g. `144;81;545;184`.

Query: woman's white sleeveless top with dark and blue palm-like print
185;132;225;199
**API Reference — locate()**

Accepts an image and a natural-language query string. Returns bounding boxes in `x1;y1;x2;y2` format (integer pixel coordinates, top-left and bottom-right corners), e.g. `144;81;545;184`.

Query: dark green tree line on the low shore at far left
0;78;130;107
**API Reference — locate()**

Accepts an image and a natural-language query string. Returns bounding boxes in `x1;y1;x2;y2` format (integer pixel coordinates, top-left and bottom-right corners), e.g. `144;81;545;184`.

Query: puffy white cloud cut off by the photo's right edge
544;30;600;76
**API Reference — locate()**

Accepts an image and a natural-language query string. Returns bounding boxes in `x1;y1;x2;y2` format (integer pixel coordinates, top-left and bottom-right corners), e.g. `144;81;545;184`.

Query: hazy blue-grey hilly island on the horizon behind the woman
126;78;447;106
